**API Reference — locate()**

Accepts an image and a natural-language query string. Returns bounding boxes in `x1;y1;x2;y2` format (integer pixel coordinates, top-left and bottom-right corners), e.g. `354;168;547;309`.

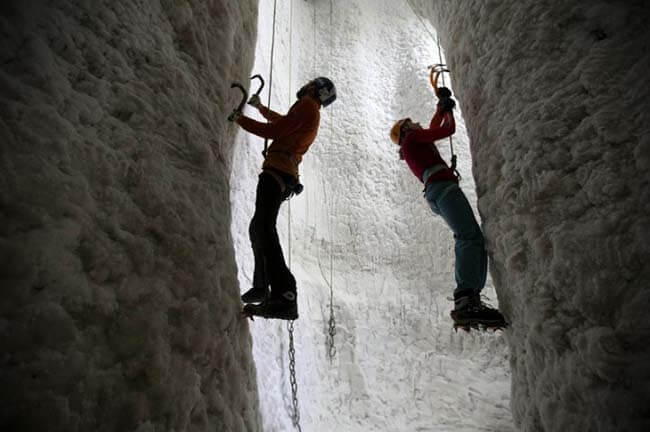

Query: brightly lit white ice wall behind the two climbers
231;0;512;432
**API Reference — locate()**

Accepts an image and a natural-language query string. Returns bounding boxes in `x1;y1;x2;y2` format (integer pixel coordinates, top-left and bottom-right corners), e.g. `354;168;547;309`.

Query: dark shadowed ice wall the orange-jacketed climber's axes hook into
0;0;259;431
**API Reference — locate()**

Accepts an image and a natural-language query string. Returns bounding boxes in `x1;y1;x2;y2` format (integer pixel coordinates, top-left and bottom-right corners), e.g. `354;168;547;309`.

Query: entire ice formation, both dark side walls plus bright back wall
0;0;650;432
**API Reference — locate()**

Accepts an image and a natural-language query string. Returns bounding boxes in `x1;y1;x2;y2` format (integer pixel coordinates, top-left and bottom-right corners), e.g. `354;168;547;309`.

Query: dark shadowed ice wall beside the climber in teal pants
420;0;650;431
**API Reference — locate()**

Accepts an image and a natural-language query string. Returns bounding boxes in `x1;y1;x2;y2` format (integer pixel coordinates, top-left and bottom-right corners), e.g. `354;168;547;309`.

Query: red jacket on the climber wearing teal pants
400;109;458;185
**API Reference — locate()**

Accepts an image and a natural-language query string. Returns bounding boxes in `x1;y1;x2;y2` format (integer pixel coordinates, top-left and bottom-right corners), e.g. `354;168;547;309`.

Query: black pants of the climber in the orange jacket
248;172;296;296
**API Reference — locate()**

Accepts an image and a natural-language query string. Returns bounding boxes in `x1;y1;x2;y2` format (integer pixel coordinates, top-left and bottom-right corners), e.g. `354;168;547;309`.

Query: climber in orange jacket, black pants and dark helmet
229;77;336;320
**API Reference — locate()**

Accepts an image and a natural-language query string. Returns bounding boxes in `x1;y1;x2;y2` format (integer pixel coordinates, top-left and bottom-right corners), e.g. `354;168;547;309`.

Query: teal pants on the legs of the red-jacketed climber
426;182;487;299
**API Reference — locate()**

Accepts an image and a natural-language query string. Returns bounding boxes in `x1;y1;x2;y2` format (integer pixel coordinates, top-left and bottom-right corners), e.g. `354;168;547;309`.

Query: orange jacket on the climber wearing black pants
237;96;320;178
